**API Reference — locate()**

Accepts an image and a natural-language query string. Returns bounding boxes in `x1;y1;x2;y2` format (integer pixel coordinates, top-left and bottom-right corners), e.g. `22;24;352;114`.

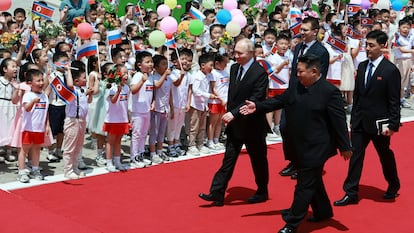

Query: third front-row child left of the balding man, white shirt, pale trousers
167;49;193;157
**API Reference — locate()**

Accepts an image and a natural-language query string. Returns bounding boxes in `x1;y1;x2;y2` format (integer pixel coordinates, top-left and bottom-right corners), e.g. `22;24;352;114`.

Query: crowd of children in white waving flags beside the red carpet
0;0;414;182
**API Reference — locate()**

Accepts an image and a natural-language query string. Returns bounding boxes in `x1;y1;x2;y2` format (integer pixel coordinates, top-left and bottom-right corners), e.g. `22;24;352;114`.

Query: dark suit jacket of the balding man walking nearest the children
226;61;269;139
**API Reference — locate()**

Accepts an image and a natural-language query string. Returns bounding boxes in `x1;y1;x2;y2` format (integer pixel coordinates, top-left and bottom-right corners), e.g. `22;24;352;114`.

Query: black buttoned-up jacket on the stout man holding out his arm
256;78;351;168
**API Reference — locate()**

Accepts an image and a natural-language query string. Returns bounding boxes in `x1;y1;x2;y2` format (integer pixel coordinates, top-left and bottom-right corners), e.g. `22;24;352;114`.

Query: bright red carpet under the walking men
0;123;414;233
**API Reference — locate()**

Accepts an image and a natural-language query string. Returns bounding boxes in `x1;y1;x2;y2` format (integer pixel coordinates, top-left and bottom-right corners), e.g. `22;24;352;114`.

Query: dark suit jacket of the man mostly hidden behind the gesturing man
289;41;329;84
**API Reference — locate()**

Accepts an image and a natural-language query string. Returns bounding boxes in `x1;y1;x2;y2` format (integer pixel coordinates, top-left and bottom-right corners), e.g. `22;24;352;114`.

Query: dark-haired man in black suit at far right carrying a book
334;31;401;206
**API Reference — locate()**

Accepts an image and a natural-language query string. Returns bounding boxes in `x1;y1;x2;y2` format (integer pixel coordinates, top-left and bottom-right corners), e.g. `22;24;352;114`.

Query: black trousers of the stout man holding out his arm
282;166;333;228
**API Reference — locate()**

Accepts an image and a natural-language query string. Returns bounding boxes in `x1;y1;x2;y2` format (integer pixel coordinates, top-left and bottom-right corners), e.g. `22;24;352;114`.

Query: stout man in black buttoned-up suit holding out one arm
241;55;352;233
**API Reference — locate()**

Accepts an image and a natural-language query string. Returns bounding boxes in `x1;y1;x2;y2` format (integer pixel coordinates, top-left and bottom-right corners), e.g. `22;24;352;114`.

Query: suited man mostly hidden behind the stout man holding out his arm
279;17;329;178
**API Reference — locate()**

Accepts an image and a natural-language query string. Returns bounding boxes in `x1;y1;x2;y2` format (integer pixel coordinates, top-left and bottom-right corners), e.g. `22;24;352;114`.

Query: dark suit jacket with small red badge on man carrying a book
351;58;401;134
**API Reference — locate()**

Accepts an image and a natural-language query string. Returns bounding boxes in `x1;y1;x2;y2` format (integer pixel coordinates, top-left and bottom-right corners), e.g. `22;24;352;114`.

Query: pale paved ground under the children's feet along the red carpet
0;105;414;190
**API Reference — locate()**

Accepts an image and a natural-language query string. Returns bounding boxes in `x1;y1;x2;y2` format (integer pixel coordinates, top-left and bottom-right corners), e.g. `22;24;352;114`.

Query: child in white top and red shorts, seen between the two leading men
266;34;293;136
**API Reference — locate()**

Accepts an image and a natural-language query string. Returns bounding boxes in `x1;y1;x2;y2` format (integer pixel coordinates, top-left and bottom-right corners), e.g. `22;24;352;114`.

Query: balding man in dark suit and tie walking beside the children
199;38;269;206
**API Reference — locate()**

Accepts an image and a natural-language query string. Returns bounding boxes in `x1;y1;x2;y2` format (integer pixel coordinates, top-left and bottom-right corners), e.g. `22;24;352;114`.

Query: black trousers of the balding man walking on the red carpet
210;134;269;200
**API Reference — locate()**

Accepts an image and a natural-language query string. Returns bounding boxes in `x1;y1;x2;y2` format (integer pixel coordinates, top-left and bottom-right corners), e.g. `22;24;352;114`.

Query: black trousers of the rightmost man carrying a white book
343;129;400;197
